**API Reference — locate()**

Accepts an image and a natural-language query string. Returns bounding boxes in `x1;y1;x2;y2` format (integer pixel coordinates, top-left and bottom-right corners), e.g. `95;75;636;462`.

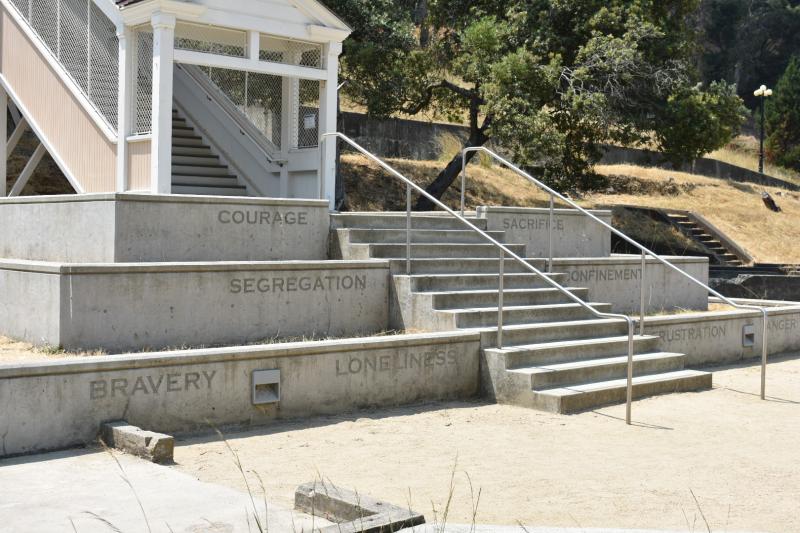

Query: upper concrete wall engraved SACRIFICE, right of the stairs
478;207;611;257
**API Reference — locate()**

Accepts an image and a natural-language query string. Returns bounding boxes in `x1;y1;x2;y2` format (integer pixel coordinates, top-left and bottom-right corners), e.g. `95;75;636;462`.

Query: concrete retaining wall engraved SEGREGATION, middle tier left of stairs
0;260;389;352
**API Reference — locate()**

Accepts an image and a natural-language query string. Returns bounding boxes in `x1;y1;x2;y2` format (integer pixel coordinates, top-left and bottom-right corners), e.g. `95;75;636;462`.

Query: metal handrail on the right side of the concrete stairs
461;146;800;400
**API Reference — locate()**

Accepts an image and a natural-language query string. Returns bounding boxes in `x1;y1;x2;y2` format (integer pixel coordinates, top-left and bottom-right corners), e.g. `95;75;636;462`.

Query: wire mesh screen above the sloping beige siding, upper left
12;0;119;129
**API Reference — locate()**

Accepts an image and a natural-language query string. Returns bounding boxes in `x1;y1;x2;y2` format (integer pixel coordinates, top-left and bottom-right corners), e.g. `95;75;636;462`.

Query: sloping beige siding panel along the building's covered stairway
0;6;116;192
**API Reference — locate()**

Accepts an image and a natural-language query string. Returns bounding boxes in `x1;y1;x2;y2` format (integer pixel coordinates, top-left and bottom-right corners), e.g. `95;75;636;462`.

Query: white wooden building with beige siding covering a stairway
0;0;350;206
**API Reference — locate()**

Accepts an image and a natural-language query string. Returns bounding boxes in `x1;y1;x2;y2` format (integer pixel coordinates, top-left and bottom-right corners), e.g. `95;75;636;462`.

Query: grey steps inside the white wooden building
172;109;247;196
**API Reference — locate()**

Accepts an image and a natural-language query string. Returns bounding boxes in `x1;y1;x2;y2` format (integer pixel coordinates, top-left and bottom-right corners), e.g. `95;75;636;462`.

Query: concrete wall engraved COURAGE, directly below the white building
0;193;330;263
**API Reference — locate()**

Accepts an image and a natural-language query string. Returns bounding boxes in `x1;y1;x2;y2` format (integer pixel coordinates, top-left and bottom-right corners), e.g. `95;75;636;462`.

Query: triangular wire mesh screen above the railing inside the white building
201;67;283;150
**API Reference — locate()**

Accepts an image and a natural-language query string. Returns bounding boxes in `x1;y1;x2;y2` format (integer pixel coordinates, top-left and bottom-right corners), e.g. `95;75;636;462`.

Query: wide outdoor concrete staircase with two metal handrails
331;213;711;413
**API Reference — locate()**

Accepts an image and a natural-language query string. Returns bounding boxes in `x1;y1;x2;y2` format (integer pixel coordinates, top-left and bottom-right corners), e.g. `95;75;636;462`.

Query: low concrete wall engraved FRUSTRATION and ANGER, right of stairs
645;304;800;366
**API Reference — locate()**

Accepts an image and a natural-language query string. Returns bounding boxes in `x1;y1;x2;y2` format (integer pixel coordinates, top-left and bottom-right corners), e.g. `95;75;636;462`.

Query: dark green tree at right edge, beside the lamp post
766;56;800;170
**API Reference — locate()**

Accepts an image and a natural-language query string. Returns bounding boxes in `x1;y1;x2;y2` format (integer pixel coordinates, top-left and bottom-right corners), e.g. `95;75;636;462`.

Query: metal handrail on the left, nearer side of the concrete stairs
320;132;635;424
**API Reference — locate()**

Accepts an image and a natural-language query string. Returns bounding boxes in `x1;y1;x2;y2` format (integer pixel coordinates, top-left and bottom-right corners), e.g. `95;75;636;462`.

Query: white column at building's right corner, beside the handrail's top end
319;42;342;210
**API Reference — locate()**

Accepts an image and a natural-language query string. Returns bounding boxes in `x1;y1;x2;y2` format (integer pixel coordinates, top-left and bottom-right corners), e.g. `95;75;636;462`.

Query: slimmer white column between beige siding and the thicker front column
117;25;136;192
